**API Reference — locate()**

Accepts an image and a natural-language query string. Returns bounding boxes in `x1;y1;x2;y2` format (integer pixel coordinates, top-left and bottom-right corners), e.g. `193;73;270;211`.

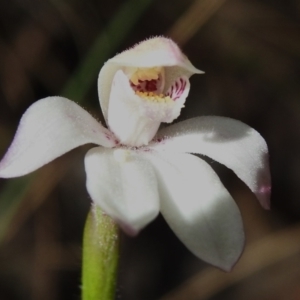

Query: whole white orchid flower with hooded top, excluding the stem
0;37;270;270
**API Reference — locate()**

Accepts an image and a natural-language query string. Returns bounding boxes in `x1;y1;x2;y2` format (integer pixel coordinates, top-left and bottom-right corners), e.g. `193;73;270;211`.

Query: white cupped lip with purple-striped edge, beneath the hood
108;70;190;147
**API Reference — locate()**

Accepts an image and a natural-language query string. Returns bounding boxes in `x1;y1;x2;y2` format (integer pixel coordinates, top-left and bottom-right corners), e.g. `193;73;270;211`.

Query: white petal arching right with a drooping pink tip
151;117;271;209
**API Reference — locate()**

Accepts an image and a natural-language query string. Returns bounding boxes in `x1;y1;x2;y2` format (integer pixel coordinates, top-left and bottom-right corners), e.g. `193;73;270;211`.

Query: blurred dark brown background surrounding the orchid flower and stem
0;0;300;300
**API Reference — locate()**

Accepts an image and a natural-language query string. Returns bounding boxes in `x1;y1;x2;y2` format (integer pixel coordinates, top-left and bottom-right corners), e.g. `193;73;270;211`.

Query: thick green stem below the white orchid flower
82;206;119;300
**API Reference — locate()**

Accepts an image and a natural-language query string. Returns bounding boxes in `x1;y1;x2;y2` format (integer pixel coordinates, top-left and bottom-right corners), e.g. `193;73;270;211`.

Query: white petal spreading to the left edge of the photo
0;97;116;178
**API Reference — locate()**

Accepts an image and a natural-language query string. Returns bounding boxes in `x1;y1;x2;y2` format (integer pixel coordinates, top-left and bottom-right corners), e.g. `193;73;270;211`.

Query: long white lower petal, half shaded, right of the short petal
146;152;244;271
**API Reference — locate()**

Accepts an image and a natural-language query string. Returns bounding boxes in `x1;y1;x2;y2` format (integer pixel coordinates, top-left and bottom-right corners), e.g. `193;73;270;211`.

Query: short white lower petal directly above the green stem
85;147;159;232
